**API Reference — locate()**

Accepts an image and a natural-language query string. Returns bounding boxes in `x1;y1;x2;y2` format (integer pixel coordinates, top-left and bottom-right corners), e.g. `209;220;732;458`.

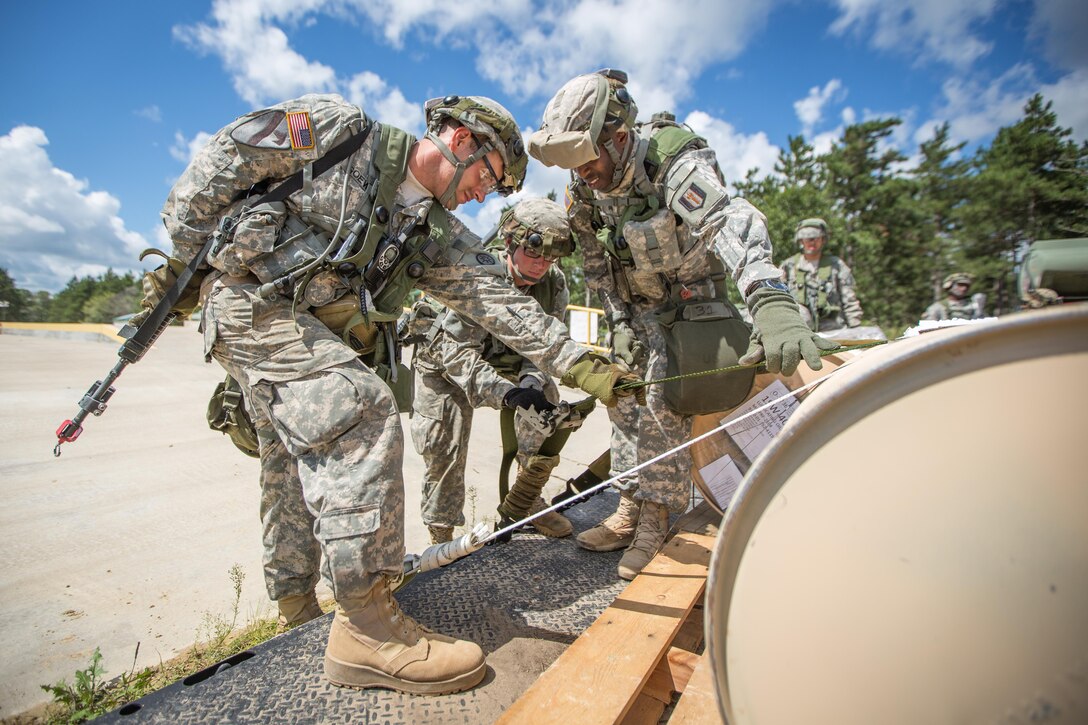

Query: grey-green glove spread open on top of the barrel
739;287;839;376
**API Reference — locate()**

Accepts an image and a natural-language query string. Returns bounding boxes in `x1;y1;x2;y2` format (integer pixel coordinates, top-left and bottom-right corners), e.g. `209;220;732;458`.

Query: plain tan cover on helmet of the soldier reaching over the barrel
529;73;608;169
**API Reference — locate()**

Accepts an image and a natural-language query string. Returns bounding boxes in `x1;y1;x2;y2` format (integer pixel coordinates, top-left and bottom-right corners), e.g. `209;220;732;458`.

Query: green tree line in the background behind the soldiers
0;95;1088;335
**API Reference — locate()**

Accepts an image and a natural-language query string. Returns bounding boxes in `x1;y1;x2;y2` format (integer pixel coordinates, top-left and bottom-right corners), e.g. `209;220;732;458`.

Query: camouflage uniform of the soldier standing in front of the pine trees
782;255;862;332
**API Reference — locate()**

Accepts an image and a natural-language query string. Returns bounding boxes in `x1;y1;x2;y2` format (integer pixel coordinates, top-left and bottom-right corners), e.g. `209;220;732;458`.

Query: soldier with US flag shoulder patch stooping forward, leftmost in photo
160;95;639;695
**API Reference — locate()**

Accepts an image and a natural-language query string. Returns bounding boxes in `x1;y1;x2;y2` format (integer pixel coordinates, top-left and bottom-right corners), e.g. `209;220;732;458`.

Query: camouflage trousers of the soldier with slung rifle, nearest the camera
201;278;405;600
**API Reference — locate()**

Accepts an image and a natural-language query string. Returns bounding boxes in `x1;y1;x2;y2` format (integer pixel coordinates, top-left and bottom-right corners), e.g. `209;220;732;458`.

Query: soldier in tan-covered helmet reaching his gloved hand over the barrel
529;70;836;579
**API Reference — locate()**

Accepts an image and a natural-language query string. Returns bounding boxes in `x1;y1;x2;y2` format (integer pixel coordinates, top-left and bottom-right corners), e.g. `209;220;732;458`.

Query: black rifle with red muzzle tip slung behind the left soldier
53;217;236;456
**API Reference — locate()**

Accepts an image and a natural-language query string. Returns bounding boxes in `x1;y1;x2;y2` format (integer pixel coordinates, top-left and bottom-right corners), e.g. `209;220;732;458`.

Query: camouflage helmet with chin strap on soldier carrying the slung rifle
423;96;529;208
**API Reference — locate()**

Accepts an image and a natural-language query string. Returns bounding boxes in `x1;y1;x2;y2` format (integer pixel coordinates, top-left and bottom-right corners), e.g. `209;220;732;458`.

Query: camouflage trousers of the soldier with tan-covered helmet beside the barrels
608;305;691;512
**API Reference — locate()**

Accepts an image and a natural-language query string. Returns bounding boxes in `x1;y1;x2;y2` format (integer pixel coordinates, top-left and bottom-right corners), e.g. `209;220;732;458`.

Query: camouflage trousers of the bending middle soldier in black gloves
410;365;559;527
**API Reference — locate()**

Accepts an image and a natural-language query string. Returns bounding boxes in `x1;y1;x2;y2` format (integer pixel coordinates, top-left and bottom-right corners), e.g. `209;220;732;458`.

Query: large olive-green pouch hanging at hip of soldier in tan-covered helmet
657;299;755;415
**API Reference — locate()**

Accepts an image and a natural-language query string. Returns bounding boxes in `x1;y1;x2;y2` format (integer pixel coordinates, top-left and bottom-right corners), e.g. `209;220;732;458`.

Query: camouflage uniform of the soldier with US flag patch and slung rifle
162;95;586;600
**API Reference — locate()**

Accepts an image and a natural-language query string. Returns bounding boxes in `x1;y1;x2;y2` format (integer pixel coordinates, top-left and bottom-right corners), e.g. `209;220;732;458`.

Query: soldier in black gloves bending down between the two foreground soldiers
411;194;573;543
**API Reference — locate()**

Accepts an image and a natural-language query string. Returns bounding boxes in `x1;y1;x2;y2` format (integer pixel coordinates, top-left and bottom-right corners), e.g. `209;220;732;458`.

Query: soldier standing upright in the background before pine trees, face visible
782;219;862;332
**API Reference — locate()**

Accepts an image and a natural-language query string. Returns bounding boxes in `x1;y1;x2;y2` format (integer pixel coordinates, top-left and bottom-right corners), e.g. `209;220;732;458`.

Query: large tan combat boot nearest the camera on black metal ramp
325;579;487;695
